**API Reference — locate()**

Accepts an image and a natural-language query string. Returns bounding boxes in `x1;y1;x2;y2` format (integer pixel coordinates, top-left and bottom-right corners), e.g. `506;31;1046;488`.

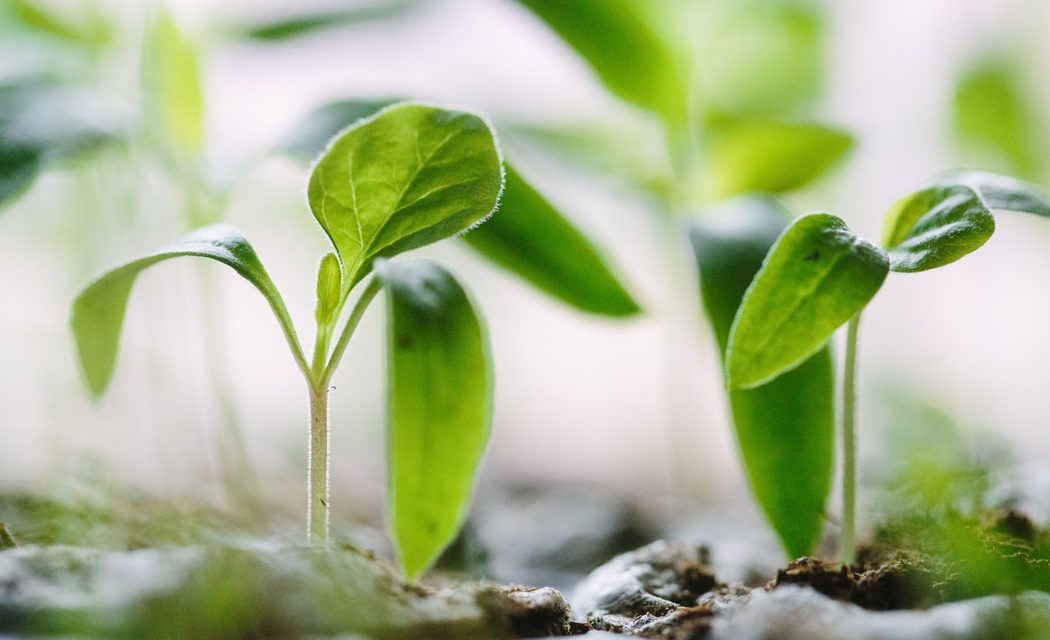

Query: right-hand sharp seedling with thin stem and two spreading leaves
726;171;1050;562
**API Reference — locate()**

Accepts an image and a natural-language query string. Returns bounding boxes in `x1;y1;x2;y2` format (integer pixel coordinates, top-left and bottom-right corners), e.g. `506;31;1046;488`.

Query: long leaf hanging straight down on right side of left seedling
376;260;492;579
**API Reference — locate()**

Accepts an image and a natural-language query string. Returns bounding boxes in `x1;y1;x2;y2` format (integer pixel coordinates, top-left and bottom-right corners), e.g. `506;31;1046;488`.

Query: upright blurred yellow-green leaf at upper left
142;10;204;153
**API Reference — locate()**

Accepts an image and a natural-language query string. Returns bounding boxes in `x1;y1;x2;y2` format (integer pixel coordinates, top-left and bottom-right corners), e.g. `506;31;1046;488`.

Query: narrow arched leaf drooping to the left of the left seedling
71;225;303;398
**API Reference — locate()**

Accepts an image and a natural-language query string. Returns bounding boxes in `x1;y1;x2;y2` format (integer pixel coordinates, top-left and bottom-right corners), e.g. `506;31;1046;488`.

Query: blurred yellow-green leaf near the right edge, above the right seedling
952;58;1048;177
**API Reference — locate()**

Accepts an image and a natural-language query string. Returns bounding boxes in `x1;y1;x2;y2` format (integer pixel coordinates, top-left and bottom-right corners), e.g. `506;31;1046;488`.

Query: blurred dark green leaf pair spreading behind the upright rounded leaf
281;100;641;317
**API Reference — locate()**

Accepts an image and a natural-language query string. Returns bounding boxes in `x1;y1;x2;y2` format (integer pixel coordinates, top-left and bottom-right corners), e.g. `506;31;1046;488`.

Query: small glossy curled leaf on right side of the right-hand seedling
883;184;995;273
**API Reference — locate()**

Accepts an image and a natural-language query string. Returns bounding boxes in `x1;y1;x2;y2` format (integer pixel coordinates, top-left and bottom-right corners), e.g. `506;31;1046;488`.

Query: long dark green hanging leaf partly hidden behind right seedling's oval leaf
690;196;835;557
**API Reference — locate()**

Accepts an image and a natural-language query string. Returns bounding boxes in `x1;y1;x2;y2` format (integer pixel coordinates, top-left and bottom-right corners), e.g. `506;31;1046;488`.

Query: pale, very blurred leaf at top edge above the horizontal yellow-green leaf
694;0;824;118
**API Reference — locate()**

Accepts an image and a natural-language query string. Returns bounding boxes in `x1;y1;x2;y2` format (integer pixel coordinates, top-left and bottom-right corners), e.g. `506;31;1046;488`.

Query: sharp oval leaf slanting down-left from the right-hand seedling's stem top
726;213;889;389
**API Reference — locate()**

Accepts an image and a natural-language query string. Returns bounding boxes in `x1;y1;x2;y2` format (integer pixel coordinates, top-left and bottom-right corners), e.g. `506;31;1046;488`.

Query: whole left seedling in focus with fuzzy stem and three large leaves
72;104;503;578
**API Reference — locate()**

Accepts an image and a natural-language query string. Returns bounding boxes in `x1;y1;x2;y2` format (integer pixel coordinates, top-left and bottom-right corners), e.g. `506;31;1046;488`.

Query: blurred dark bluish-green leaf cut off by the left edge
0;79;120;207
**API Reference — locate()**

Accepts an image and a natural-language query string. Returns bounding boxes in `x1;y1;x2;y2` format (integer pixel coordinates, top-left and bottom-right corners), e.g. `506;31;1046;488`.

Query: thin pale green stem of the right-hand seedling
839;313;860;564
